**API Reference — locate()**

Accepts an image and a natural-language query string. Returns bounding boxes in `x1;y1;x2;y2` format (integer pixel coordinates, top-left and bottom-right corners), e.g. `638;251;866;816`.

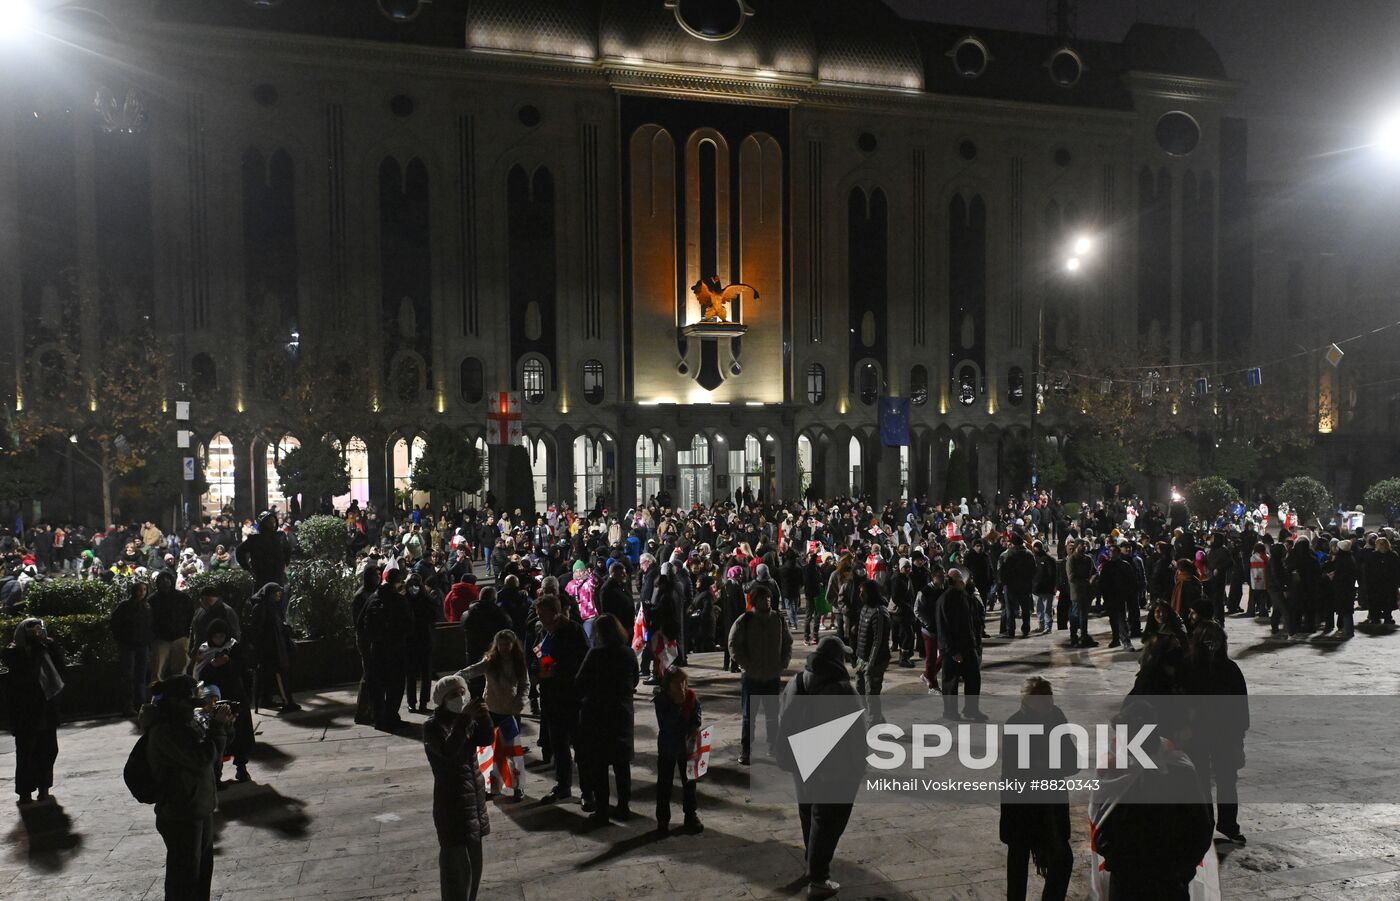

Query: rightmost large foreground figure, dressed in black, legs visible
1182;621;1249;845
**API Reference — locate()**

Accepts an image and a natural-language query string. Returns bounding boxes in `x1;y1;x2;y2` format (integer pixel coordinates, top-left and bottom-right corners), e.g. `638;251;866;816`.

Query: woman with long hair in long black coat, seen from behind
575;612;641;825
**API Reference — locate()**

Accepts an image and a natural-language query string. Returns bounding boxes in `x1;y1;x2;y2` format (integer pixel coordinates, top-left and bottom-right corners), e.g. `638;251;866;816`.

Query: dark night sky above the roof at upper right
885;0;1400;179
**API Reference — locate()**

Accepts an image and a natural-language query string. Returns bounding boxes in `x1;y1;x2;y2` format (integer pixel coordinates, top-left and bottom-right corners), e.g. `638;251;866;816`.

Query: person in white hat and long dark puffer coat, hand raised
423;676;491;901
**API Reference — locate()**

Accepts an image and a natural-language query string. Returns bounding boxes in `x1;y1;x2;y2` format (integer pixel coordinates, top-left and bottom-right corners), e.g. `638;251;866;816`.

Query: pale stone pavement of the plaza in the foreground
0;620;1400;901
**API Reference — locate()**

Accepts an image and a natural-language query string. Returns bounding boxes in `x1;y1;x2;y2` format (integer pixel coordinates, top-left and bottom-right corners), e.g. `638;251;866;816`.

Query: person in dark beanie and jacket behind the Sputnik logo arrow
777;635;865;898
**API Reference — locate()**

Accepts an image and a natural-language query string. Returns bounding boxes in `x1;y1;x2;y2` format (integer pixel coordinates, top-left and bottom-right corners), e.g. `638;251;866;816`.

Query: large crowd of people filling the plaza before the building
0;494;1400;898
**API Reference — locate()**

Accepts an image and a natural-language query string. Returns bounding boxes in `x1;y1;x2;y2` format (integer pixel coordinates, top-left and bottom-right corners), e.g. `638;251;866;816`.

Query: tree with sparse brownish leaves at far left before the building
15;326;174;523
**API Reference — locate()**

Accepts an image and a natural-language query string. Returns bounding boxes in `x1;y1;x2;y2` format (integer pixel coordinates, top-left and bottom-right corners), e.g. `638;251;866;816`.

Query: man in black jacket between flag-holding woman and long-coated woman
535;595;588;803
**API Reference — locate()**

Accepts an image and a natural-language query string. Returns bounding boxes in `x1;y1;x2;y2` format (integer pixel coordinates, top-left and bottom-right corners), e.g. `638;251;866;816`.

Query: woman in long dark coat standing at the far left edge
0;617;64;804
